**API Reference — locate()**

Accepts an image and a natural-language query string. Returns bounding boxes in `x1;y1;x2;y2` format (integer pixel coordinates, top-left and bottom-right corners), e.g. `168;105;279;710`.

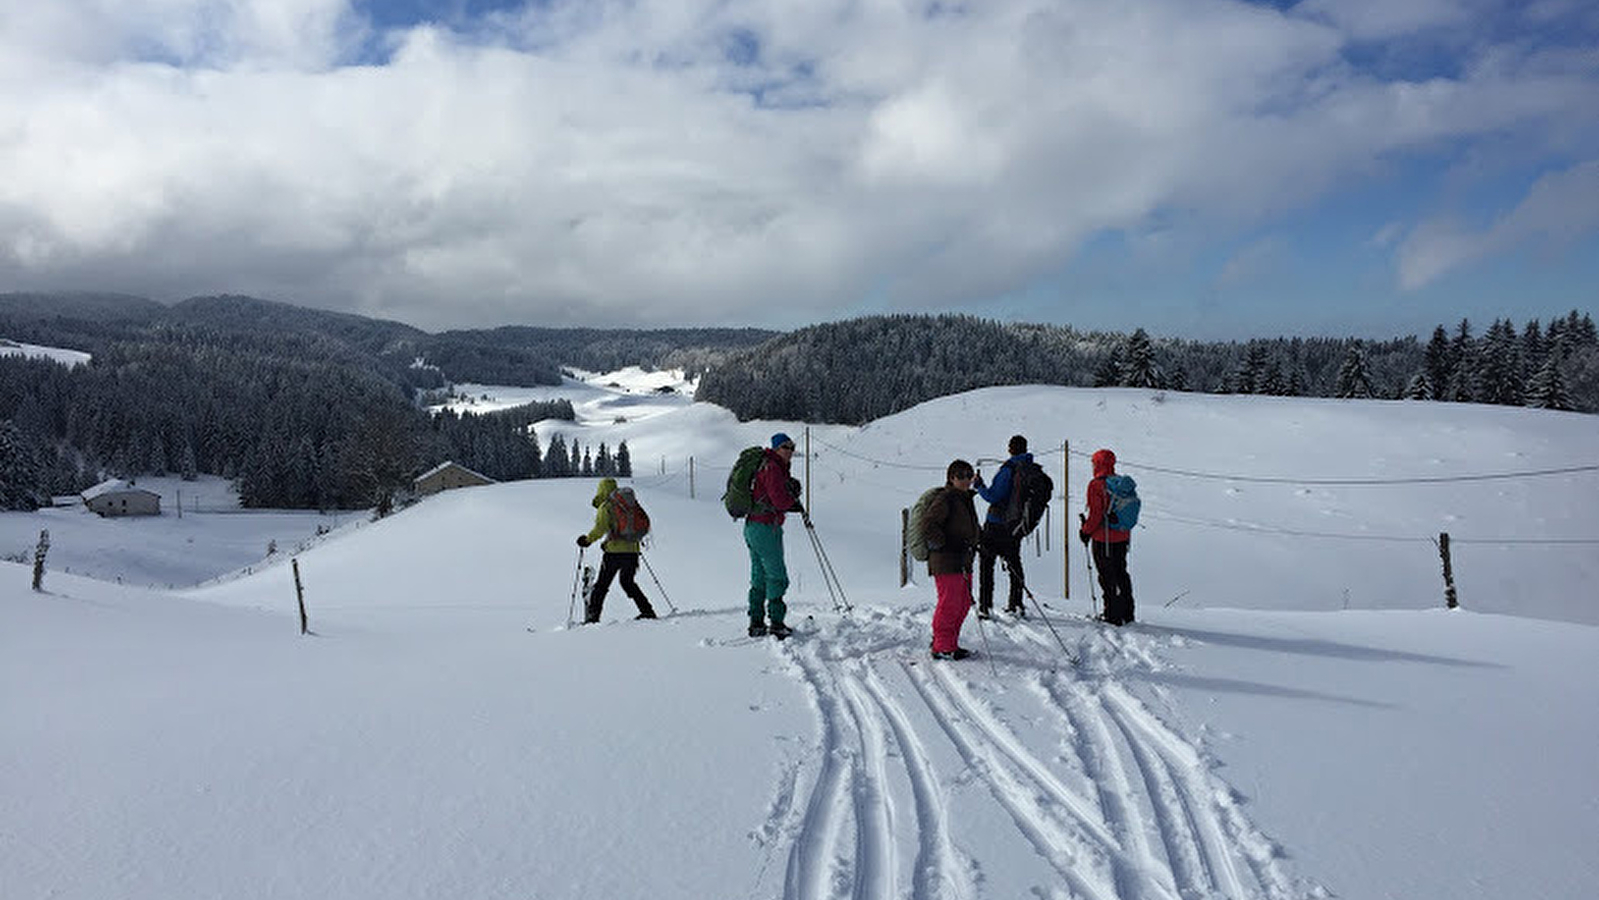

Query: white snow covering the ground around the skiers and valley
0;376;1599;900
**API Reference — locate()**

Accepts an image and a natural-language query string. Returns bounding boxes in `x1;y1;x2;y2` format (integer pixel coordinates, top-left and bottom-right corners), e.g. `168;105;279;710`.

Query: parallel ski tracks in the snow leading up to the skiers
755;609;1327;900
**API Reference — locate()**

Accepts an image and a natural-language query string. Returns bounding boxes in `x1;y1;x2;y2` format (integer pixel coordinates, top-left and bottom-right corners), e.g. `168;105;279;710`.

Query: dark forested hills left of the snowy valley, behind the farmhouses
0;294;771;508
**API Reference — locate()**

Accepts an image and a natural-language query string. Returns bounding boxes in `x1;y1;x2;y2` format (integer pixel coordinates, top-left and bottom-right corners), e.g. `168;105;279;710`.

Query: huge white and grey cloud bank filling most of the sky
0;0;1596;328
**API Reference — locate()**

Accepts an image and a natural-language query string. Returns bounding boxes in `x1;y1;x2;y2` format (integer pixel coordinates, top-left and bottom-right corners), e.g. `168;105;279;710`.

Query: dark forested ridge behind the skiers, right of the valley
697;310;1599;425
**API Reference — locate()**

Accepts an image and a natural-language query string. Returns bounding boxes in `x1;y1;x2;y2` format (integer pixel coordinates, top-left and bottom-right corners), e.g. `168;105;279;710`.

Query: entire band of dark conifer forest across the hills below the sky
0;294;1599;512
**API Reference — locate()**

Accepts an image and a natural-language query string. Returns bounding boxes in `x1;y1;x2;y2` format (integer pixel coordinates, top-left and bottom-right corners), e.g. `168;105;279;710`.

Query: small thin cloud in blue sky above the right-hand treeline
1398;160;1599;289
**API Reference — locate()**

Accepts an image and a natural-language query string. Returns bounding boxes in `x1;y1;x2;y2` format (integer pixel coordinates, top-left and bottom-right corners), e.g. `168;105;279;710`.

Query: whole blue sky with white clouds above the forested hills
0;0;1599;337
